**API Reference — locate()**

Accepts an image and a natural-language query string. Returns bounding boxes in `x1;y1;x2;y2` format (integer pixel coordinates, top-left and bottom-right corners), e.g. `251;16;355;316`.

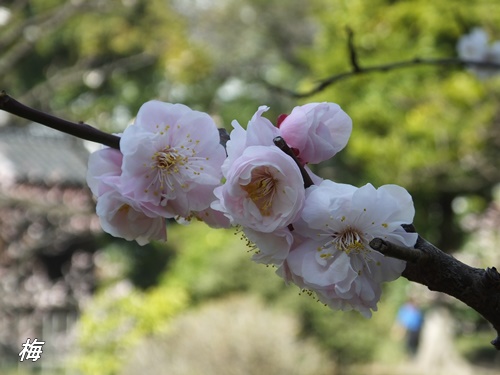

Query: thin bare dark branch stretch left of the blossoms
0;91;120;150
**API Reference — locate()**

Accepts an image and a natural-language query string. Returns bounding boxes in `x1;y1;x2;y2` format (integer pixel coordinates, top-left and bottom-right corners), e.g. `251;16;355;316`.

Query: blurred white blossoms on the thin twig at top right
457;27;500;78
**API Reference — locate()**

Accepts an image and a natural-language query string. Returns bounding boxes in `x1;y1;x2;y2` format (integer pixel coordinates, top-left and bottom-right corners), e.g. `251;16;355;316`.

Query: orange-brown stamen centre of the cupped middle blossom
241;167;278;216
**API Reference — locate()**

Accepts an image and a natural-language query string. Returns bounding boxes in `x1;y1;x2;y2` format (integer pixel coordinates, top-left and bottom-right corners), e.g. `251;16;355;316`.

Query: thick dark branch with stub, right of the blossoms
370;236;500;350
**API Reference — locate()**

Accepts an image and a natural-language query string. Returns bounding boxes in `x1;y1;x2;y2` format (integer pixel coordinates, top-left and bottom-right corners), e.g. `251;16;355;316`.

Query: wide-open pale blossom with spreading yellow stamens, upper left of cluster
120;100;225;217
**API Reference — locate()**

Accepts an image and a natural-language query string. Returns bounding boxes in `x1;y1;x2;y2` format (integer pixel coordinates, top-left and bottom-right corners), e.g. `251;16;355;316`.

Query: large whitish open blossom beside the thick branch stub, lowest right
279;180;417;317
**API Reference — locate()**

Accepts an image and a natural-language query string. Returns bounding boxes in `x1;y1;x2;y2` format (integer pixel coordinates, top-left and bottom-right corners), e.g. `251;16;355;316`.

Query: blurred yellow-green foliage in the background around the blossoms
0;0;500;374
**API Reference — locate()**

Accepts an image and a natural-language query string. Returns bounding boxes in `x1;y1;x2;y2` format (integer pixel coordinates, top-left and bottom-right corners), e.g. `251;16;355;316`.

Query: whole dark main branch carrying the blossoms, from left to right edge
0;91;500;350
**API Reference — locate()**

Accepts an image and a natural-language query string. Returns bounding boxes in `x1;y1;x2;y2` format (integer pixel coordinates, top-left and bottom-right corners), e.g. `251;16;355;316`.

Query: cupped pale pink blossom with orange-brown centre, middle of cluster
212;145;305;233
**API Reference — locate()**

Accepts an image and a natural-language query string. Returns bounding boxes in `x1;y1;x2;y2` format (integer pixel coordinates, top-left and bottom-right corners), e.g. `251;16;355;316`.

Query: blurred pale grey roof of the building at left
0;124;88;186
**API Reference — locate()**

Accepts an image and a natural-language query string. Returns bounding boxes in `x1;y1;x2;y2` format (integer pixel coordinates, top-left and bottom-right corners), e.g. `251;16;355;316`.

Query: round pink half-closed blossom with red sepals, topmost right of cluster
278;102;352;164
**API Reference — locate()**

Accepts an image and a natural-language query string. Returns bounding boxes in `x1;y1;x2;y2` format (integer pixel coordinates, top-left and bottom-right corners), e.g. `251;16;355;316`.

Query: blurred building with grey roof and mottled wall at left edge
0;124;101;373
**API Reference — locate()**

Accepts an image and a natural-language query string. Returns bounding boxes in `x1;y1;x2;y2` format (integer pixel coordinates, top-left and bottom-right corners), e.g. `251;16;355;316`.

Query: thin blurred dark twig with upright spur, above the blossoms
263;56;500;99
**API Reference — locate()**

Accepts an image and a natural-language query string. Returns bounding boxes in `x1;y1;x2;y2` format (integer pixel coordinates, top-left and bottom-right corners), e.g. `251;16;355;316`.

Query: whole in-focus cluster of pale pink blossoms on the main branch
88;101;417;317
